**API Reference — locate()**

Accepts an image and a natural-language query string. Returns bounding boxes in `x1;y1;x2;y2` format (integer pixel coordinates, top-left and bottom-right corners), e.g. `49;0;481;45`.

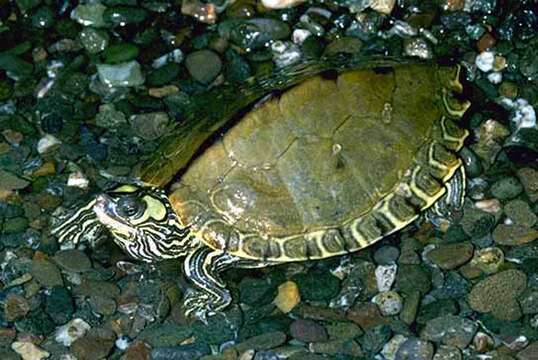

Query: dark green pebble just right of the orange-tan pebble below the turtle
293;271;340;301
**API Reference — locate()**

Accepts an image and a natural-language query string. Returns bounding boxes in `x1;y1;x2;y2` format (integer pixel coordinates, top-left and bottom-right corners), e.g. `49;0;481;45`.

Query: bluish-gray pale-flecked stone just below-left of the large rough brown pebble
420;315;478;349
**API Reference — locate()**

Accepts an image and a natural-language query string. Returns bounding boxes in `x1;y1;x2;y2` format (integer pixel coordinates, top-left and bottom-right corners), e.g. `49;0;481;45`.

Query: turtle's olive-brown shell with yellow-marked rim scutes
170;65;465;261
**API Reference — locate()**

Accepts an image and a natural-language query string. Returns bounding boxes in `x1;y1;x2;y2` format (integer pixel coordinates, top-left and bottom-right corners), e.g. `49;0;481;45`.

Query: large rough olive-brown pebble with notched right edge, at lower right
468;270;527;321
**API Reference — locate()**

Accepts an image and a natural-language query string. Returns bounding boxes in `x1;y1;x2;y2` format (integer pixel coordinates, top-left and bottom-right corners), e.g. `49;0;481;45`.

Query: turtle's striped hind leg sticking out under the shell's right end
425;166;465;227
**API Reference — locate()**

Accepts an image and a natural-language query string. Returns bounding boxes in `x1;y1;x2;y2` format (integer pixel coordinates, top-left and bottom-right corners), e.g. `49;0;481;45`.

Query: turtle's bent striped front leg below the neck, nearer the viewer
183;245;238;322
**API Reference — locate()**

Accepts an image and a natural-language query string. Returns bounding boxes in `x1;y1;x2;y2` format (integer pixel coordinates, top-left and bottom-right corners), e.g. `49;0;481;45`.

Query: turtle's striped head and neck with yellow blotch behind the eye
93;185;198;262
